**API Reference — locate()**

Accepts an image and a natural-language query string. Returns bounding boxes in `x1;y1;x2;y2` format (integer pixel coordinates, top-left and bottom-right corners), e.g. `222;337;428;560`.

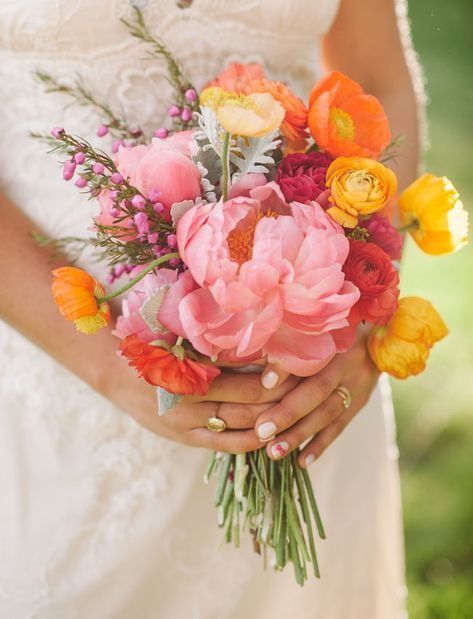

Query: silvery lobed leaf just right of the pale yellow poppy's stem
230;131;281;182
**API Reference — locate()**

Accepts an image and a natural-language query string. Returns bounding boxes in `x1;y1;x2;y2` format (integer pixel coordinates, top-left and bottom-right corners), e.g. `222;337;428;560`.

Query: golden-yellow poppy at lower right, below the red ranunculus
368;297;448;378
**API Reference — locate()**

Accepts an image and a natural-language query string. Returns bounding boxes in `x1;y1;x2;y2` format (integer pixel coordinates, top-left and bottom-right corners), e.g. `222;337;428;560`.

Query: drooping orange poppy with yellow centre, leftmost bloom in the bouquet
52;267;110;334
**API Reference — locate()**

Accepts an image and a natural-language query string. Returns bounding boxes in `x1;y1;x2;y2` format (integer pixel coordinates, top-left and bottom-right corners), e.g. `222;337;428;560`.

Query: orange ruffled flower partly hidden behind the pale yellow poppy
246;79;309;150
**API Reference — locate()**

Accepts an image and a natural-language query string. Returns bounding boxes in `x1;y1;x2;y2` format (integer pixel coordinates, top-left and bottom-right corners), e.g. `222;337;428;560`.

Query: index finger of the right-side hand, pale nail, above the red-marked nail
256;366;341;442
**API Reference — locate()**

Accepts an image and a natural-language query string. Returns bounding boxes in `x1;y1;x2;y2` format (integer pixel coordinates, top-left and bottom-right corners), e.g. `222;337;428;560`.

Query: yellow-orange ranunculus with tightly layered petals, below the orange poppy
326;157;397;228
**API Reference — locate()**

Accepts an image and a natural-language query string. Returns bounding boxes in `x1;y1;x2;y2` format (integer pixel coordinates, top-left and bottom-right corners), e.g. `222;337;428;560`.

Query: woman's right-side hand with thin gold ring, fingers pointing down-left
255;334;379;467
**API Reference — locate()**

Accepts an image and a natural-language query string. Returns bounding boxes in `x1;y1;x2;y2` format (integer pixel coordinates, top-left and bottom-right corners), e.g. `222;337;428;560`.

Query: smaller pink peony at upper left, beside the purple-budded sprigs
115;131;201;216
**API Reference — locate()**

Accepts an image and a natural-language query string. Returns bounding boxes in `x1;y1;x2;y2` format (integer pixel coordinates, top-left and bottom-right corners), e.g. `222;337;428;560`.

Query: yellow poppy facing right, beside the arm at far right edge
399;174;468;255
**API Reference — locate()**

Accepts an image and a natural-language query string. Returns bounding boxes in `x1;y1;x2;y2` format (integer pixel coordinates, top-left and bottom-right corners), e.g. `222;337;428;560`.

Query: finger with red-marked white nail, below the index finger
266;393;346;460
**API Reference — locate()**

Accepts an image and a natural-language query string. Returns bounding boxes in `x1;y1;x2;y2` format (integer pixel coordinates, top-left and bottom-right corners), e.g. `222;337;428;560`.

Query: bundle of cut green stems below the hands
205;449;325;586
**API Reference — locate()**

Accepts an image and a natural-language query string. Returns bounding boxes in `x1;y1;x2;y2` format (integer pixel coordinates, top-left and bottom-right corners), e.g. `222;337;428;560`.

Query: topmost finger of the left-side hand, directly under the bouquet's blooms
194;372;301;404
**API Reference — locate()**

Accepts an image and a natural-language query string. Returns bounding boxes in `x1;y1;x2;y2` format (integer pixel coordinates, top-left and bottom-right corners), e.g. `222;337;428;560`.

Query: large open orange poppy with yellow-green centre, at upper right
309;71;391;159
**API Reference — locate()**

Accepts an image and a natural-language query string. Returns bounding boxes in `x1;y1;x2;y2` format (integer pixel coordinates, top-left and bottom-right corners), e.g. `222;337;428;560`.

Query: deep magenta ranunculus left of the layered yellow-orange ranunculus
276;152;332;203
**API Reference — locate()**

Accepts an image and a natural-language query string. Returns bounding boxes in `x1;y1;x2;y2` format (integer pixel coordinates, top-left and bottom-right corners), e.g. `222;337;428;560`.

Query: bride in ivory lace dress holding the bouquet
0;0;418;619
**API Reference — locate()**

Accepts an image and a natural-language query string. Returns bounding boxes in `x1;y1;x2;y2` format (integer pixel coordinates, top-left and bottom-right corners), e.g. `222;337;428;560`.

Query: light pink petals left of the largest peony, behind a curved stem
113;269;177;344
